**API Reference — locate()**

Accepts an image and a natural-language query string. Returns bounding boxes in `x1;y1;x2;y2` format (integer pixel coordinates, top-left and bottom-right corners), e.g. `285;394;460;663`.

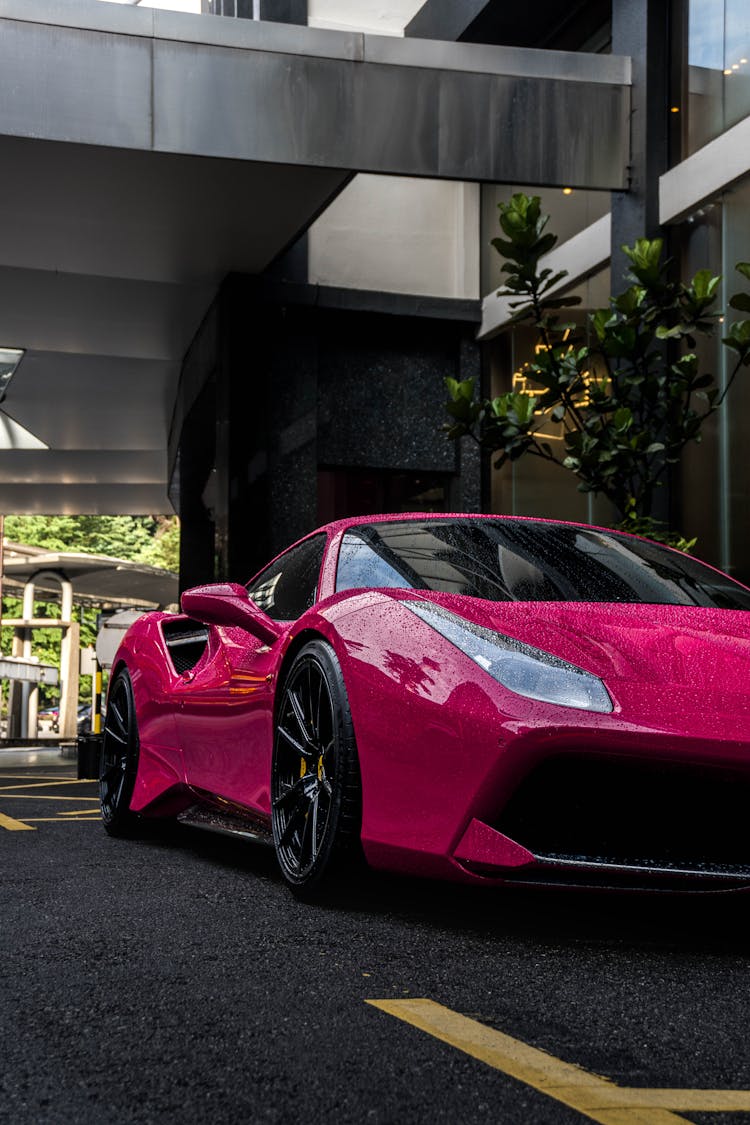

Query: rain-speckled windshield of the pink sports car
336;519;750;610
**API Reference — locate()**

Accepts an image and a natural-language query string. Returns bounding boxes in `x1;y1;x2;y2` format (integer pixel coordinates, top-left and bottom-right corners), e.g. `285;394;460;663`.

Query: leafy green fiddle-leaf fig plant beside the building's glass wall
443;194;750;531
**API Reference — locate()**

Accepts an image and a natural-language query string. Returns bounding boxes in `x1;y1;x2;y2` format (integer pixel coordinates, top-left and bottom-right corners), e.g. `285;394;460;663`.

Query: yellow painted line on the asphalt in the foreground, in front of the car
367;1000;750;1125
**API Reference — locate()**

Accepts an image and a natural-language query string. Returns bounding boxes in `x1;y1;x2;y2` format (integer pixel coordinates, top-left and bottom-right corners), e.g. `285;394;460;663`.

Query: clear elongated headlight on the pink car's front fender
401;602;612;712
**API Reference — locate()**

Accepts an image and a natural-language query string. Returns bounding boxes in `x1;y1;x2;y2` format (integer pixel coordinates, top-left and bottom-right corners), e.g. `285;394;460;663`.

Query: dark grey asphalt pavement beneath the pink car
0;755;750;1125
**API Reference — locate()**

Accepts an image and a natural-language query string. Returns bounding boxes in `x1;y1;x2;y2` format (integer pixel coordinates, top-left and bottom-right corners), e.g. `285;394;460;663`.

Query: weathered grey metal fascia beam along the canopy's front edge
0;0;630;189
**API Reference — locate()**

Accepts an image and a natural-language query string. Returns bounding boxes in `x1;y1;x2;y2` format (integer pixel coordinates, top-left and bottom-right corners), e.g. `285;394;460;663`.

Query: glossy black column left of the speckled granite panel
217;277;317;582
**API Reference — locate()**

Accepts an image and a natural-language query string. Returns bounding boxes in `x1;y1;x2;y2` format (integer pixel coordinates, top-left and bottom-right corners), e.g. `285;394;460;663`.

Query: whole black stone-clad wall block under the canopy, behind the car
171;275;482;588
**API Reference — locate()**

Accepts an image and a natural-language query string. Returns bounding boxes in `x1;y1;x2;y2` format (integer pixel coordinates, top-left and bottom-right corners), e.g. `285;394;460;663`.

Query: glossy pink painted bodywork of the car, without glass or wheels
106;515;750;882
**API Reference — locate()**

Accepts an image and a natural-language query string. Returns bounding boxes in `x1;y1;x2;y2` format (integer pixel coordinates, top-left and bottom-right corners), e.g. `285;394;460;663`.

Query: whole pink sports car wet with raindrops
100;514;750;897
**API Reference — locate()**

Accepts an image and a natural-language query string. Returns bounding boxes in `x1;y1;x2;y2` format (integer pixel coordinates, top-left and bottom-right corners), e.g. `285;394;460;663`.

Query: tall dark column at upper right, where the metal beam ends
612;0;670;293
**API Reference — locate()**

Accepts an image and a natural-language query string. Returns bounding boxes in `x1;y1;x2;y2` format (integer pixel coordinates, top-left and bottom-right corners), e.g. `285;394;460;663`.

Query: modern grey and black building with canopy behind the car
0;0;750;584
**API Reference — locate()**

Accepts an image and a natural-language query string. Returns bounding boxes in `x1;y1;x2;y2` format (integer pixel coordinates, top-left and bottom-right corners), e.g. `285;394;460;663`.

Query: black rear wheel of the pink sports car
99;668;139;836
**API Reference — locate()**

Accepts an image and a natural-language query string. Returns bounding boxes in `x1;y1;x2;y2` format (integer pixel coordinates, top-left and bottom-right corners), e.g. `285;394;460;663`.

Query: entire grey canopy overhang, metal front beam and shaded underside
0;0;630;513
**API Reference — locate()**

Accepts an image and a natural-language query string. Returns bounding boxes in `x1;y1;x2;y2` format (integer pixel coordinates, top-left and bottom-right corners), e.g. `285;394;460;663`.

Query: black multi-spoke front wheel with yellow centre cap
271;640;361;898
